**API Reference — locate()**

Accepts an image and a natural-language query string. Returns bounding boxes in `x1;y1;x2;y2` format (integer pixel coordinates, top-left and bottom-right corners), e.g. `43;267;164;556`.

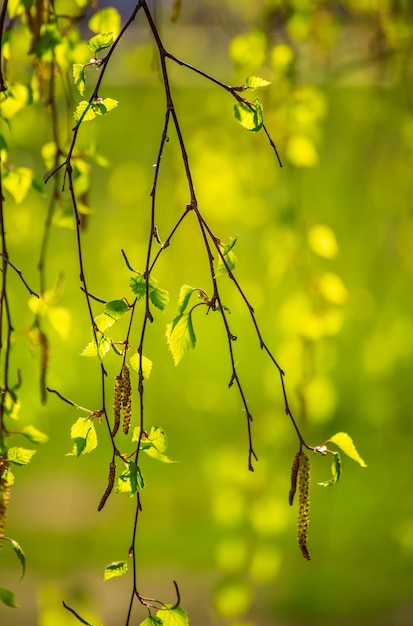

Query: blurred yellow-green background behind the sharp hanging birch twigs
0;0;413;626
